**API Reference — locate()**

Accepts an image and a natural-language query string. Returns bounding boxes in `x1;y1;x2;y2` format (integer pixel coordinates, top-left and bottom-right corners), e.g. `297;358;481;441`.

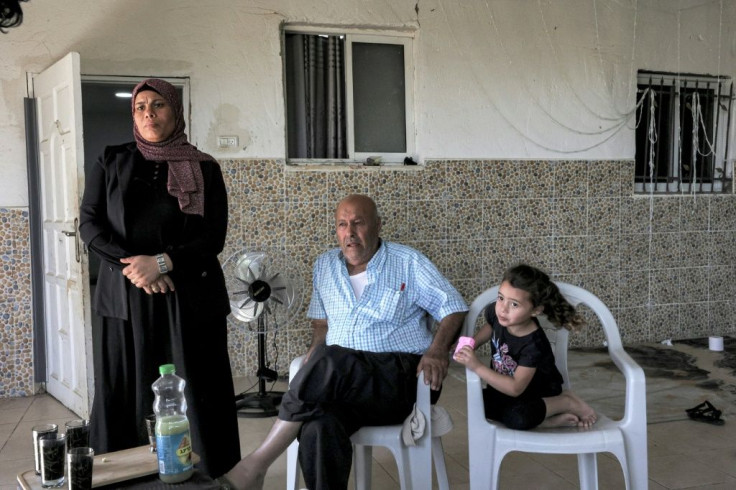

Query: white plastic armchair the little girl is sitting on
464;282;648;490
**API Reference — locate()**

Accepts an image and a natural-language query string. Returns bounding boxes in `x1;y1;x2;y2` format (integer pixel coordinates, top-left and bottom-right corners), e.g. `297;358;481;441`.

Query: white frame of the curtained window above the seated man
281;24;416;165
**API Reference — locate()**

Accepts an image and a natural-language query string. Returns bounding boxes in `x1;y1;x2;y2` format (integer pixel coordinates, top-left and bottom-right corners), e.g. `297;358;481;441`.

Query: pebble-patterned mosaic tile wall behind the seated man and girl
221;160;736;374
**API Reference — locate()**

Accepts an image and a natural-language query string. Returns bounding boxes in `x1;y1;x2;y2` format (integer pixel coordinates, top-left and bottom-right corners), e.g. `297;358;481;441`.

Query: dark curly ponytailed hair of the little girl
503;264;585;332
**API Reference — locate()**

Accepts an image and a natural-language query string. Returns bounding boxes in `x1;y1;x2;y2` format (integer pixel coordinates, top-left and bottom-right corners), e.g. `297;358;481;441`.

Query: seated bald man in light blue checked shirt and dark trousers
220;195;468;490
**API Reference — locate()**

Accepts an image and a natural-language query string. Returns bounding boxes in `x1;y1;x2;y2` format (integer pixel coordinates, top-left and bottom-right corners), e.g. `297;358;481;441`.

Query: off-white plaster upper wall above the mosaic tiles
0;0;736;207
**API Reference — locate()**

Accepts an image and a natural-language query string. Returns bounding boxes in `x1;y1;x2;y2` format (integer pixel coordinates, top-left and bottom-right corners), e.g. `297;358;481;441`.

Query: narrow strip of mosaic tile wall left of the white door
0;208;33;398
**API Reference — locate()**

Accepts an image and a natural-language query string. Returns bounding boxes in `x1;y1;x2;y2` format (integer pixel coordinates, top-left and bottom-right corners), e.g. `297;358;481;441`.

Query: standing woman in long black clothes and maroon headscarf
79;79;240;477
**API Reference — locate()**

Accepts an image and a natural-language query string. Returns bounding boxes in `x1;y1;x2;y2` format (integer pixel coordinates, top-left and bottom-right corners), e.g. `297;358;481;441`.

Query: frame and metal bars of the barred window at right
634;70;733;195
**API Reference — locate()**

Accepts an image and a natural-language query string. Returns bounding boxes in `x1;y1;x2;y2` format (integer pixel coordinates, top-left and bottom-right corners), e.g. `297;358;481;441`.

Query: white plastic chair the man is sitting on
286;356;450;490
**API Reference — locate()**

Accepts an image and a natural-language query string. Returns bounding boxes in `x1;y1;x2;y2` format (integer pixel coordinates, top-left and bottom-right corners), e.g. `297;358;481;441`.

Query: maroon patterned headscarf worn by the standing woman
131;78;217;216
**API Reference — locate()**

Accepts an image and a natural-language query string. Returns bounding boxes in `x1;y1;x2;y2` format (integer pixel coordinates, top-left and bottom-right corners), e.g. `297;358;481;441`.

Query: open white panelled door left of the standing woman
33;53;93;418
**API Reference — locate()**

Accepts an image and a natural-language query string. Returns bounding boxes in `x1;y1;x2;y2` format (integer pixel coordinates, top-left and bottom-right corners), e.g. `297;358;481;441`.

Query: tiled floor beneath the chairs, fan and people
0;345;736;490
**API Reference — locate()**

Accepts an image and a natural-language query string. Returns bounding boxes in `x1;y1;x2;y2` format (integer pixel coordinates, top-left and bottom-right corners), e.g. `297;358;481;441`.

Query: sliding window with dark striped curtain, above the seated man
284;28;414;163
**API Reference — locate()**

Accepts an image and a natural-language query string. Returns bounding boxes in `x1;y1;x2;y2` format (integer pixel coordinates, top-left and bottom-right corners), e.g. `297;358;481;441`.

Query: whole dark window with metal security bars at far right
635;71;733;194
